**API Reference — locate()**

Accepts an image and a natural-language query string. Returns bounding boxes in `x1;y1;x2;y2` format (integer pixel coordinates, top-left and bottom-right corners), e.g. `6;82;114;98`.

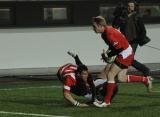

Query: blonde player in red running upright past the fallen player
92;16;152;107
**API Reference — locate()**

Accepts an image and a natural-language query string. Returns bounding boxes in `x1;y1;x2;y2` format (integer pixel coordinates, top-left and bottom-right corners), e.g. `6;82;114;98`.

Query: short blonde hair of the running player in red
92;16;107;26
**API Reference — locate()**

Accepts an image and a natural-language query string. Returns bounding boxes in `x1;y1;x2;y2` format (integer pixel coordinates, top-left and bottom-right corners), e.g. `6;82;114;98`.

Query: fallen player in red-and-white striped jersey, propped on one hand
57;52;118;107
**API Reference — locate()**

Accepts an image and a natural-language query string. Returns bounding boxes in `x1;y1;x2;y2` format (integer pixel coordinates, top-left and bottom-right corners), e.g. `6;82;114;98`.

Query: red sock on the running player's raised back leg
127;75;148;85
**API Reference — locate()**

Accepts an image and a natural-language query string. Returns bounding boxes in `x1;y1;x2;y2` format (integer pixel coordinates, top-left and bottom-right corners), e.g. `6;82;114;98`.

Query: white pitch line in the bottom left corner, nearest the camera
0;111;69;117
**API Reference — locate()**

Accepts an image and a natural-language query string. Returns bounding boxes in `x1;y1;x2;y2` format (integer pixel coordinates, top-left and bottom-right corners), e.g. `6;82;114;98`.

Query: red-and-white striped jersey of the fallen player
58;63;77;92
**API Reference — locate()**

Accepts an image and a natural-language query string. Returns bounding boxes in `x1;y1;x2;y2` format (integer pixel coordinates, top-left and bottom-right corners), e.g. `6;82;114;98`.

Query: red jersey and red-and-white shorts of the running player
102;26;134;66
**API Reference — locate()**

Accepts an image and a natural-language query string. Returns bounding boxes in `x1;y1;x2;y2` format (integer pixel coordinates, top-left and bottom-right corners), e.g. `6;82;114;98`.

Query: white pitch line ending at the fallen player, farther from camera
0;86;62;91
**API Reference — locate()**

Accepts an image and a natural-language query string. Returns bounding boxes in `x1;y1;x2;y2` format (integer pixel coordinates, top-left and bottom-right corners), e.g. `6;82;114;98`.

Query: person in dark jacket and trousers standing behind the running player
112;0;150;77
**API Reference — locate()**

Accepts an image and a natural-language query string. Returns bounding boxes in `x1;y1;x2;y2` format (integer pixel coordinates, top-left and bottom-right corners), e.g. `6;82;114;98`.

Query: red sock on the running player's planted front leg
105;81;116;105
